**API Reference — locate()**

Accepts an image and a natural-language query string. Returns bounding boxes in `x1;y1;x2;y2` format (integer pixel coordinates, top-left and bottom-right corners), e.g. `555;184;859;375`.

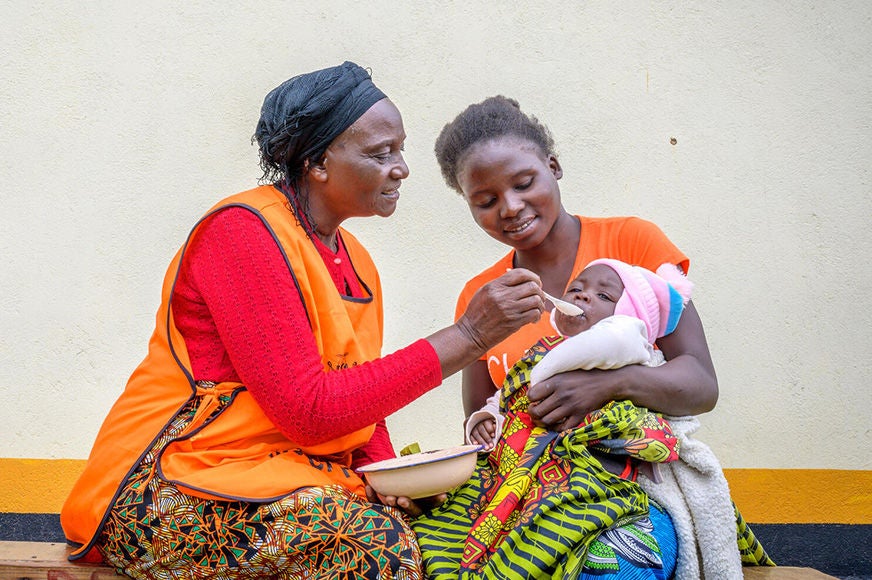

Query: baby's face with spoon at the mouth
554;264;624;336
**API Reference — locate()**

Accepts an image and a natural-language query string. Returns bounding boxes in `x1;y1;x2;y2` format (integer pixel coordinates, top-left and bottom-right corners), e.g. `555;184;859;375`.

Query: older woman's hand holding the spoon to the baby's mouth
457;268;545;349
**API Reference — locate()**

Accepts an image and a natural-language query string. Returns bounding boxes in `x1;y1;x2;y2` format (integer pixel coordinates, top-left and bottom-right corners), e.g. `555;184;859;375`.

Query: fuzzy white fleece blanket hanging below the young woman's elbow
638;417;743;580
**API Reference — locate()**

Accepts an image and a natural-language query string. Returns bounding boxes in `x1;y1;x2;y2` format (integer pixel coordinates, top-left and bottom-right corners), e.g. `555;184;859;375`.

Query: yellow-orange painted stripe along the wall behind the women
0;458;872;524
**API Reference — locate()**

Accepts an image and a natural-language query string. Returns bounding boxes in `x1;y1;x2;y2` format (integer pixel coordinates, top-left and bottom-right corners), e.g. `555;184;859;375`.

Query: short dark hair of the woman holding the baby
434;95;555;193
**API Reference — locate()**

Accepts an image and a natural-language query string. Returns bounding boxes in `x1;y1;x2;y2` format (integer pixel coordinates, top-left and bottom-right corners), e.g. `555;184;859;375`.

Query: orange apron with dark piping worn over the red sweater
61;186;383;559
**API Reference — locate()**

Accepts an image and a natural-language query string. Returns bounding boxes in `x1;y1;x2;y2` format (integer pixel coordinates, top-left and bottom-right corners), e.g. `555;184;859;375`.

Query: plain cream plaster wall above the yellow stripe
0;0;872;469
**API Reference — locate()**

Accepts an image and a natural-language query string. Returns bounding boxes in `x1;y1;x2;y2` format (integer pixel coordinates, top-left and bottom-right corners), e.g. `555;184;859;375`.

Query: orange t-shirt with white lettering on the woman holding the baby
454;216;690;388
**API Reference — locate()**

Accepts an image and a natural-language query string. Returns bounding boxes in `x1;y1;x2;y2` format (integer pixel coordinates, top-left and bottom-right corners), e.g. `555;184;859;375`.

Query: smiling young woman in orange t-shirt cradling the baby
415;96;718;579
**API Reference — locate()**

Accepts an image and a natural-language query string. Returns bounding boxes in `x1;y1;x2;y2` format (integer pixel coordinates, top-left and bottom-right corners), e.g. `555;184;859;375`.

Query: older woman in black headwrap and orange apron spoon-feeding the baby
61;62;544;578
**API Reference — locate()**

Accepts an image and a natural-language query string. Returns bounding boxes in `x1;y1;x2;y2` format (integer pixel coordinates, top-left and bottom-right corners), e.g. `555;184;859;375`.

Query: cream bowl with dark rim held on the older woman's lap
357;445;481;499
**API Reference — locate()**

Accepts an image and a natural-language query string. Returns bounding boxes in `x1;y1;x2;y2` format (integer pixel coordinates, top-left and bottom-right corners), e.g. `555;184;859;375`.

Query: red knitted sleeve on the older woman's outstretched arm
173;208;442;445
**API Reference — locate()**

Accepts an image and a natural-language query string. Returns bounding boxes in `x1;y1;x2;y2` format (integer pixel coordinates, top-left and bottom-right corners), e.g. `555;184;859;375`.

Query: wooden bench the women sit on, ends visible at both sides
0;542;835;580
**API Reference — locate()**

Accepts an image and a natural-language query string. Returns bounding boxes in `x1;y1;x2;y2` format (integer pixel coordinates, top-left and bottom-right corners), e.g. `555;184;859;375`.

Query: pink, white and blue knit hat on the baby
586;258;693;344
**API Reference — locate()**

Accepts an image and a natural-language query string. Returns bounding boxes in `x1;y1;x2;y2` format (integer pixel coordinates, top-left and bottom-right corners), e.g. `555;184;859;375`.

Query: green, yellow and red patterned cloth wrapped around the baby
412;340;678;579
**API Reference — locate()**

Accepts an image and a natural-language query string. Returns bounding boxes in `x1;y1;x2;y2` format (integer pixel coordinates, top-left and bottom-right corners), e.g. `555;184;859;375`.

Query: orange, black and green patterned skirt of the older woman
97;386;423;580
